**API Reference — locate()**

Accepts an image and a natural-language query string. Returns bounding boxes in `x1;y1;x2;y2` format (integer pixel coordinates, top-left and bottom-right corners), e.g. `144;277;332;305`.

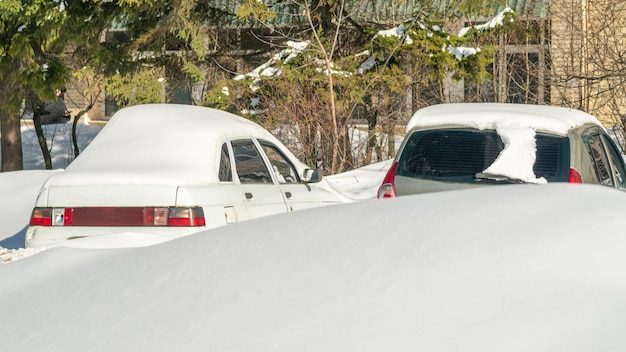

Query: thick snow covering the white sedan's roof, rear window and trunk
48;104;302;186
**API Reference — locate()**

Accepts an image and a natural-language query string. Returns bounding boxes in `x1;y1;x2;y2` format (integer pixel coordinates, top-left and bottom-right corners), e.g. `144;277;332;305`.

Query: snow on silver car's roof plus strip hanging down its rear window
407;103;601;183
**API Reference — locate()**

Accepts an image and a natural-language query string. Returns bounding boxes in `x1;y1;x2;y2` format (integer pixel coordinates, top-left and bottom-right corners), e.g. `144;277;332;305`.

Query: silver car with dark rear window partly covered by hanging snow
378;103;626;198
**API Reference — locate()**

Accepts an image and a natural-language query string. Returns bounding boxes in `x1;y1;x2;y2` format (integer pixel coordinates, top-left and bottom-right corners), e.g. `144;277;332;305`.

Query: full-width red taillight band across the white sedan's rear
30;207;205;226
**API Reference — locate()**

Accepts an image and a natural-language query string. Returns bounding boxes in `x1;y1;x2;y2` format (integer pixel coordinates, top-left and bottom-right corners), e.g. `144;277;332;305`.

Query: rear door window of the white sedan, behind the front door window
231;139;272;183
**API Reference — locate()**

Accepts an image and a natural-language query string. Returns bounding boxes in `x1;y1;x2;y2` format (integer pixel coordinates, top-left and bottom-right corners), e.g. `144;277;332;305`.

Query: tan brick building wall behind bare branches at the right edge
550;0;626;128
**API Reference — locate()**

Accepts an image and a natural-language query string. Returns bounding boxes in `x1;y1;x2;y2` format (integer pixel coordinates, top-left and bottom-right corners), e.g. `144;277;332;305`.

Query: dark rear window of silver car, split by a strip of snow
397;129;569;182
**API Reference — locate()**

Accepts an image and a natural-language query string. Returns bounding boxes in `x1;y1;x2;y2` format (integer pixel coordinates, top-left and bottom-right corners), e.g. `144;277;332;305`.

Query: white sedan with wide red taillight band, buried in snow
25;104;350;247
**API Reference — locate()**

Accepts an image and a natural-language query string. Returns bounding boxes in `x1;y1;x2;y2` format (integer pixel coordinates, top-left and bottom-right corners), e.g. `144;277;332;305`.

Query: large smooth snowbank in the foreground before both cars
0;184;626;352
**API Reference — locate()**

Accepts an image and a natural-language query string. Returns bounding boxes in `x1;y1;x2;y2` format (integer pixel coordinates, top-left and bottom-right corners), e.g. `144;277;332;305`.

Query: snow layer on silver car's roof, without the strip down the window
407;103;601;136
